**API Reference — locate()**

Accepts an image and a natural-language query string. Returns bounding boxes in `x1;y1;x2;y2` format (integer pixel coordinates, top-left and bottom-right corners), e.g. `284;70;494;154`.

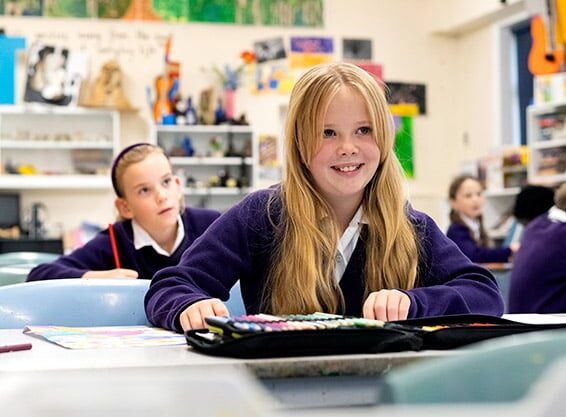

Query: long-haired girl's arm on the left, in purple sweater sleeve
145;193;268;331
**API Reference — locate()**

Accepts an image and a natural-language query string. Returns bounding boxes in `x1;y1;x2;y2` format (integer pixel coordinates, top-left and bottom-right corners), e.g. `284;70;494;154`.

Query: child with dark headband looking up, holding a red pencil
28;143;220;281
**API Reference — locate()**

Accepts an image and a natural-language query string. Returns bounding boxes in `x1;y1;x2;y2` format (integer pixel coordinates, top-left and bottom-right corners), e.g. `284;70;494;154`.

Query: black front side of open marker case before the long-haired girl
185;328;422;358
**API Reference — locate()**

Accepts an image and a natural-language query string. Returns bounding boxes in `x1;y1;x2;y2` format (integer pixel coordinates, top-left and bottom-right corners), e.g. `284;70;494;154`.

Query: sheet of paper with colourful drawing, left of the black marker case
24;326;187;349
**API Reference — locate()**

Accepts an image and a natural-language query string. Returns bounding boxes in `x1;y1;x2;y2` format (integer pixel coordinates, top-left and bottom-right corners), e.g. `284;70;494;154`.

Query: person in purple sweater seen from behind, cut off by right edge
509;183;566;313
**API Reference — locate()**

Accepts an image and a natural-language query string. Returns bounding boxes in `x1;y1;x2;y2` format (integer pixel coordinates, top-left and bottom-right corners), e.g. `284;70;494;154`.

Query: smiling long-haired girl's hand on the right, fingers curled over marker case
363;290;411;321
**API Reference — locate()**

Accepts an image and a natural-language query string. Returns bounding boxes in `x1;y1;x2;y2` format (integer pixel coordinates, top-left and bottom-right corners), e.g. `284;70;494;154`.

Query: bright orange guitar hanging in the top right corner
529;16;564;75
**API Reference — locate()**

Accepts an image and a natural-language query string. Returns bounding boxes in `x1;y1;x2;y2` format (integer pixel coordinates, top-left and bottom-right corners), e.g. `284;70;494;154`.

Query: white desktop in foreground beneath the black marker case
0;330;458;378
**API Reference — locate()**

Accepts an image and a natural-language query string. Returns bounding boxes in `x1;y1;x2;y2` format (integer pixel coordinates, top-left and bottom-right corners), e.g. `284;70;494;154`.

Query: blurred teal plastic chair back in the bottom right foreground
377;330;566;404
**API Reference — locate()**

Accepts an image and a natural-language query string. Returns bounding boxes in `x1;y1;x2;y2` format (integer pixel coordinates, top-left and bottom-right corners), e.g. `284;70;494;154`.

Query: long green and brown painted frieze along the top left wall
0;0;324;27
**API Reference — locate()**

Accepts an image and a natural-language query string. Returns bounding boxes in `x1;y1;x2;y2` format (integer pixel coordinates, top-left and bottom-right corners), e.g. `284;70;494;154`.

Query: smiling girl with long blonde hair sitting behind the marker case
145;63;503;331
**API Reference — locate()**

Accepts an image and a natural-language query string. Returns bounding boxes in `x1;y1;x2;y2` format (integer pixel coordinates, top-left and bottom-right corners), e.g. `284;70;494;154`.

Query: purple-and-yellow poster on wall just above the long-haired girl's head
289;36;334;68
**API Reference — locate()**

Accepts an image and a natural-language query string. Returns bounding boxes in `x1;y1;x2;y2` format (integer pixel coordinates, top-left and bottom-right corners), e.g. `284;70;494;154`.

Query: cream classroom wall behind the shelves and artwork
0;0;528;236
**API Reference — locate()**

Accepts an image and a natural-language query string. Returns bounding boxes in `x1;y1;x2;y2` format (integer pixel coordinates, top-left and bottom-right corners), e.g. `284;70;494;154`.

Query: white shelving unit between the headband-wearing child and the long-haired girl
152;125;258;211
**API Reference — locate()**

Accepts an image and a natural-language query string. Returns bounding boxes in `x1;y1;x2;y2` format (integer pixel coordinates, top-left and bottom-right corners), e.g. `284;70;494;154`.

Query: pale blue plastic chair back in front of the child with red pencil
0;278;150;329
